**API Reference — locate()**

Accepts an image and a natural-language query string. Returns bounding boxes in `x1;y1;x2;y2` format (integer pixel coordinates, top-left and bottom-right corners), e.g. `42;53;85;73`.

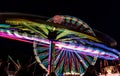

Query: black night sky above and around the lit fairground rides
0;0;120;73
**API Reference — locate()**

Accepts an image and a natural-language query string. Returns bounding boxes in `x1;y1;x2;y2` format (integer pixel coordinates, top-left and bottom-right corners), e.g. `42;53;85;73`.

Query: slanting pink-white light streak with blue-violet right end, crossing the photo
0;30;120;60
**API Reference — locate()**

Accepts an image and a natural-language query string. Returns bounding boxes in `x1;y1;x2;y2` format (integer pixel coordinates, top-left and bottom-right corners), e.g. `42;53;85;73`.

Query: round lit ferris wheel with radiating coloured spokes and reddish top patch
34;15;119;75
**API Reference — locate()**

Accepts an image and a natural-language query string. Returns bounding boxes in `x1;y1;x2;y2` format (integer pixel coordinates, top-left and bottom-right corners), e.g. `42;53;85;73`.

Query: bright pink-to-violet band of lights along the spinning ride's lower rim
0;30;119;60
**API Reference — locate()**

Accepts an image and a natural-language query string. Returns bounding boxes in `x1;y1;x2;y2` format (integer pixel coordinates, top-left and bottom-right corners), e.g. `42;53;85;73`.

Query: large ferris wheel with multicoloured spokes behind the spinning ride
34;15;101;75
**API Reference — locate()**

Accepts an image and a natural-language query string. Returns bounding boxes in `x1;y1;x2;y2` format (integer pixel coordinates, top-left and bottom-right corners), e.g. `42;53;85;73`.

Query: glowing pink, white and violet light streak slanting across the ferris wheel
0;30;118;59
